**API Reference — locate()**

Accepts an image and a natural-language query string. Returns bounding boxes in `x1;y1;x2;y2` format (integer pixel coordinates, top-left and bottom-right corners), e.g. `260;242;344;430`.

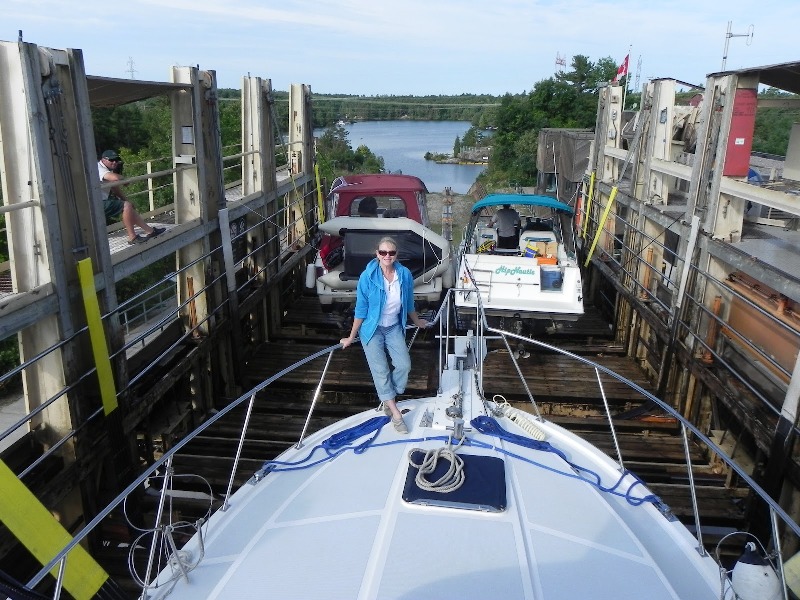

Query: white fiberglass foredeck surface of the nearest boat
150;340;719;600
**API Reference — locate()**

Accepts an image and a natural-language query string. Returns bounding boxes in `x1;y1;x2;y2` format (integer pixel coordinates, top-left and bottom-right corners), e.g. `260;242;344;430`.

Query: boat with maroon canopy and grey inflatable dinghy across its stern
306;174;454;311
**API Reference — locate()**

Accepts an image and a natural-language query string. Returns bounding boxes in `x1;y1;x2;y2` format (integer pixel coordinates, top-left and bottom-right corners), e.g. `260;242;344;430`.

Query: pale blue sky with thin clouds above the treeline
0;0;800;95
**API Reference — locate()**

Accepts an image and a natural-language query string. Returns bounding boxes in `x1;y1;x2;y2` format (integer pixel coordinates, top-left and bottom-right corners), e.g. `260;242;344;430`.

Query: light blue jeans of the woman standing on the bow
362;323;411;402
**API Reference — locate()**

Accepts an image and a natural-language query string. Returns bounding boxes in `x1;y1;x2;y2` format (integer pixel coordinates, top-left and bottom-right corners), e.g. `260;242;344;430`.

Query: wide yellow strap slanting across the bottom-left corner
0;461;108;600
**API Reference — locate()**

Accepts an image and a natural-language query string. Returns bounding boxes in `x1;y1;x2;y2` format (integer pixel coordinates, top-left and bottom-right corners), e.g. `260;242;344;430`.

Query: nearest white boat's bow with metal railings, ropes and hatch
83;292;800;600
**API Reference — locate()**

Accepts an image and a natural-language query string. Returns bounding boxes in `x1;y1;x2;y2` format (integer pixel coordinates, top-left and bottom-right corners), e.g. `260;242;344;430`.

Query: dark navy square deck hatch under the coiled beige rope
403;450;506;512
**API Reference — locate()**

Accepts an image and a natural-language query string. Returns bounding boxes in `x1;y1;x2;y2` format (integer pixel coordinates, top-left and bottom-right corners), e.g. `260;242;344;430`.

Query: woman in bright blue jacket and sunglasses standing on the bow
340;237;428;433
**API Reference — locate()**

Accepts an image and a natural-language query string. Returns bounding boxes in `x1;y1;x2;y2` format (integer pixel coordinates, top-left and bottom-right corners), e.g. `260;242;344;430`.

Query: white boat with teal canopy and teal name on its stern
455;194;583;328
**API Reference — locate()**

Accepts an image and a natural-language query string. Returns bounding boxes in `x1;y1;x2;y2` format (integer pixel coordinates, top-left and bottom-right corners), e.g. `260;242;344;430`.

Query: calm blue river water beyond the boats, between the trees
345;121;484;194
